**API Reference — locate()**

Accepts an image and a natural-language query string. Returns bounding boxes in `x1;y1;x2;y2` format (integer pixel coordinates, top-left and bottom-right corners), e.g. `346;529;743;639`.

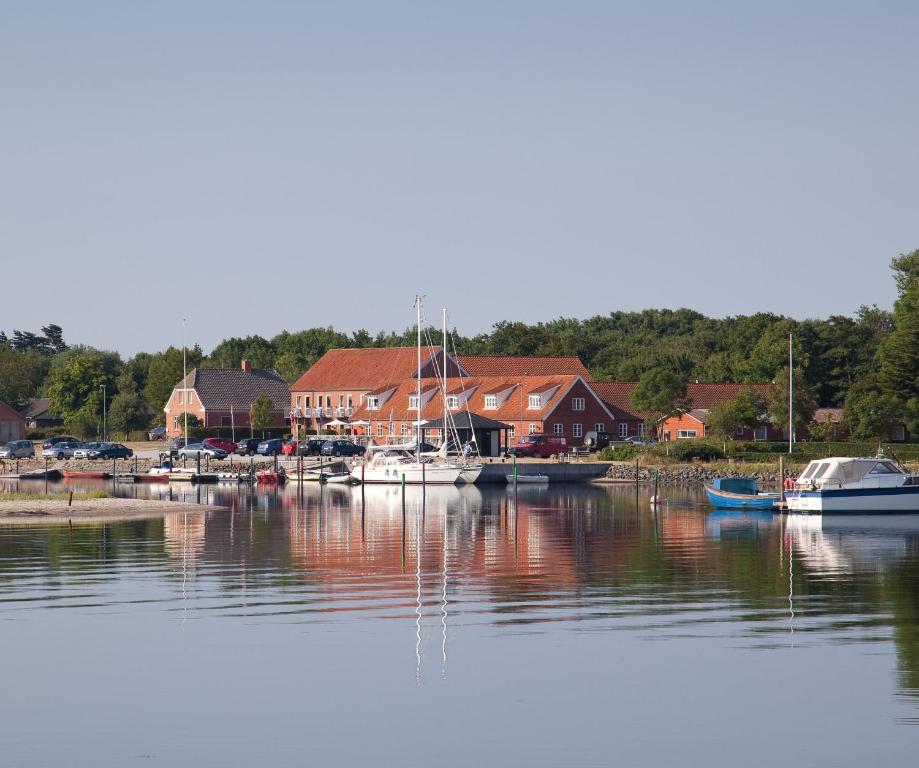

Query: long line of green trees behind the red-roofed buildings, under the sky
0;249;919;436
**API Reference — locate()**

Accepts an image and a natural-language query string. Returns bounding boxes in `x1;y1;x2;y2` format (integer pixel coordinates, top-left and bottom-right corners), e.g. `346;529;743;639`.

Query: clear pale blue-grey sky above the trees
0;0;919;355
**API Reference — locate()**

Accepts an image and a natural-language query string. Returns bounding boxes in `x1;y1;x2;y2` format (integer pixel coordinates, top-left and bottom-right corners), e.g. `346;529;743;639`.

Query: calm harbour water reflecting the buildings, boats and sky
0;486;919;766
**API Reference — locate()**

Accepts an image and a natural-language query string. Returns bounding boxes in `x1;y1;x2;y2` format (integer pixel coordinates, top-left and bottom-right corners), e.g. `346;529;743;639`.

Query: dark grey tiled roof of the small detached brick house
176;368;290;411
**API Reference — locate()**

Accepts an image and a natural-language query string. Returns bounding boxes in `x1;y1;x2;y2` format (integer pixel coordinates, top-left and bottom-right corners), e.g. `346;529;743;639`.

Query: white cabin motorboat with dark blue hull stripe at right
785;456;919;513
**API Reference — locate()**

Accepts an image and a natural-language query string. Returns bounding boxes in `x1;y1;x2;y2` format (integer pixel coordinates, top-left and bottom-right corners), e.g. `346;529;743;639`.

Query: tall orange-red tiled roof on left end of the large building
291;347;440;392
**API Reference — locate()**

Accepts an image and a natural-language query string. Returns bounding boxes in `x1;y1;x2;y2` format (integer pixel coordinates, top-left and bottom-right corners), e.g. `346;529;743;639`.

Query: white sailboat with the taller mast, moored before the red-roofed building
351;296;463;485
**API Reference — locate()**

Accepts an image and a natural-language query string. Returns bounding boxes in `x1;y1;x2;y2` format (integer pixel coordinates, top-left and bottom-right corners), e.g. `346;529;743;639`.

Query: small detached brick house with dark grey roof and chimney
163;360;290;437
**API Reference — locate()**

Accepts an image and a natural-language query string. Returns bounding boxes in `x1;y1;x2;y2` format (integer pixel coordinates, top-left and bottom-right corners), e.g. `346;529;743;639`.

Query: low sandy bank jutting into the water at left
0;499;226;525
